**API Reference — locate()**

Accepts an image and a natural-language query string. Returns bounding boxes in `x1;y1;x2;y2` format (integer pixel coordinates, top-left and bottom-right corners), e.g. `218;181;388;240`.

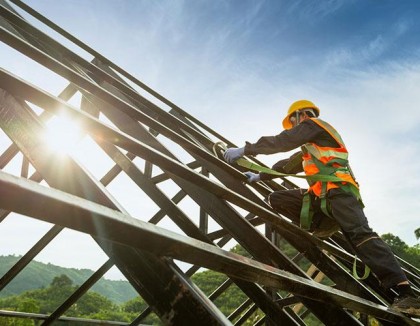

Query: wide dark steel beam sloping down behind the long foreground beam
0;91;227;324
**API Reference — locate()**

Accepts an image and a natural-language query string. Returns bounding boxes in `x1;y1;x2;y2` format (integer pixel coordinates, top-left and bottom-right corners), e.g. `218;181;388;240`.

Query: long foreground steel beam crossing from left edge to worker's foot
0;172;416;325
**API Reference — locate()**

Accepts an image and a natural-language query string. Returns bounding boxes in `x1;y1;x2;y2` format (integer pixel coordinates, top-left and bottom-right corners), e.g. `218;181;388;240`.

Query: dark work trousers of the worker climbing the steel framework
269;189;407;289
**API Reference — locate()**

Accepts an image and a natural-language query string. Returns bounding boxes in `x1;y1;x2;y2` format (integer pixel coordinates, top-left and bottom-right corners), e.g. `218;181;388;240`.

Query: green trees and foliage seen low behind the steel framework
0;234;420;326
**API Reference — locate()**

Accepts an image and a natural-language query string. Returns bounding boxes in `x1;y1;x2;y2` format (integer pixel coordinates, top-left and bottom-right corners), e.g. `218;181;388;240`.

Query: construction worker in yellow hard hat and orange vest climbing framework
224;100;420;317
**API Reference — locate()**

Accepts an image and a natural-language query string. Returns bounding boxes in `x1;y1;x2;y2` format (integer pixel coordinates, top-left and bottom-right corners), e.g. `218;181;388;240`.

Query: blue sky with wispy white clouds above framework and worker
0;0;420;278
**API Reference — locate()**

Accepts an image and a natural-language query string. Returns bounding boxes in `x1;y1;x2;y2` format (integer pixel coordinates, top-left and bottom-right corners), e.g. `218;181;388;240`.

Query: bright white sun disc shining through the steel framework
44;116;82;154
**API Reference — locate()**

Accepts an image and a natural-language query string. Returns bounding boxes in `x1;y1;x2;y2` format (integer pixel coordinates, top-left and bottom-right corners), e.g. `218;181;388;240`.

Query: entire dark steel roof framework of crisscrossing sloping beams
0;0;420;326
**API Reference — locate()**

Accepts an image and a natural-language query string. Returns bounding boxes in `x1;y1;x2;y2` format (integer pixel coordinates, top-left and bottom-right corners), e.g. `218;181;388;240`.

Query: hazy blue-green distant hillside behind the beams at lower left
0;256;138;304
